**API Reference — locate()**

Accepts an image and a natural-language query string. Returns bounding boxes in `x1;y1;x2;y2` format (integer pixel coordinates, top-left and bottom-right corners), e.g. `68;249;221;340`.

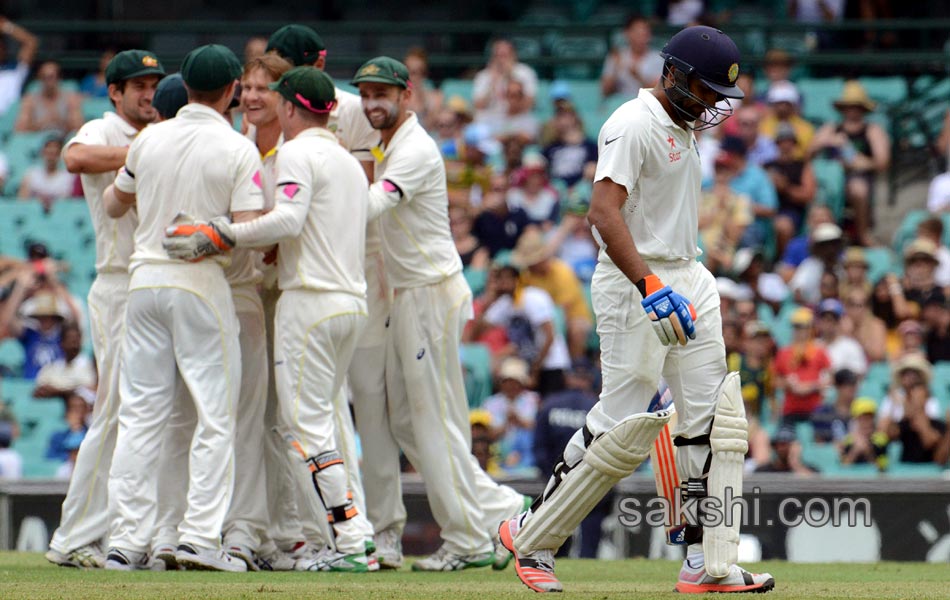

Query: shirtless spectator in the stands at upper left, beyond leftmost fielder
13;61;83;135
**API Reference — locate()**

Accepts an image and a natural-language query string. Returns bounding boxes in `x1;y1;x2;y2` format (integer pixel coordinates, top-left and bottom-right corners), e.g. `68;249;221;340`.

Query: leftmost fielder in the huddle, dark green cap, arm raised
46;50;165;567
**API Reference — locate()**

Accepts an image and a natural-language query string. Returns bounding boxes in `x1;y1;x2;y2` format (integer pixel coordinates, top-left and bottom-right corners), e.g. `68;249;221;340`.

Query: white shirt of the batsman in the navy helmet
594;89;702;264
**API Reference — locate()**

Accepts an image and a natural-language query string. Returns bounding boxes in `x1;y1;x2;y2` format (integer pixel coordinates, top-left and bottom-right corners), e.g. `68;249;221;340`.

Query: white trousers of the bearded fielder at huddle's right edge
385;273;522;554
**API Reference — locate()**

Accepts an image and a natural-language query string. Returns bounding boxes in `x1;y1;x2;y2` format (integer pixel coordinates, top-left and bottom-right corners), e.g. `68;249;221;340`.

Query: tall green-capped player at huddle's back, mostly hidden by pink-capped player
267;24;392;568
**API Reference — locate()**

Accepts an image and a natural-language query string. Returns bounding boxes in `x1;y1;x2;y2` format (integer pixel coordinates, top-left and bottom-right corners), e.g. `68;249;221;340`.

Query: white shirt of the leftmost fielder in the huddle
63;112;139;273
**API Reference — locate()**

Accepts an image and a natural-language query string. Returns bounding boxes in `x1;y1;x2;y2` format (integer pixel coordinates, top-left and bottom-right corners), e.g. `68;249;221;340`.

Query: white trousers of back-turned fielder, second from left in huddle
109;263;241;552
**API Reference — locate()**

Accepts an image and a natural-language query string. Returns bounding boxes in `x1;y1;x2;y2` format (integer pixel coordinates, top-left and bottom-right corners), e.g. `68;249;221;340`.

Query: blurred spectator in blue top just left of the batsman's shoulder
544;105;597;188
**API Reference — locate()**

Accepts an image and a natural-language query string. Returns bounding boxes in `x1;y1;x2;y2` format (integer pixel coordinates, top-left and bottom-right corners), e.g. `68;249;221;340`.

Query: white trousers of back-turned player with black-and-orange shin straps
274;290;372;554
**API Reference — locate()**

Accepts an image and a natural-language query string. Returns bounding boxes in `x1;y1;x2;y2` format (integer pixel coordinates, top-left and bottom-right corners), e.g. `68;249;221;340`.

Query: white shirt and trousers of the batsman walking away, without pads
524;89;726;552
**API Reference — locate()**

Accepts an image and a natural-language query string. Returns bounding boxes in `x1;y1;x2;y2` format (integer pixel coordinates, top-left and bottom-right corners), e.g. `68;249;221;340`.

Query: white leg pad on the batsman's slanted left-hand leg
515;411;670;554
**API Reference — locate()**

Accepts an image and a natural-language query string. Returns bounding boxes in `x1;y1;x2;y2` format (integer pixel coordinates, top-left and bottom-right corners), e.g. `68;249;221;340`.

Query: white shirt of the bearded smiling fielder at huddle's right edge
371;113;462;289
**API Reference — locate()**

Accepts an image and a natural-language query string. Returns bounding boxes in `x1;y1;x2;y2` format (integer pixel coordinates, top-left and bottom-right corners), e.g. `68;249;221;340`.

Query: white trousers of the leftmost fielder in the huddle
49;273;129;554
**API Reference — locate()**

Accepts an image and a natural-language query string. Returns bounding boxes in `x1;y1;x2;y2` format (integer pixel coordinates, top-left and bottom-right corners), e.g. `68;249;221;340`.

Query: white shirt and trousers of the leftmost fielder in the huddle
50;112;138;554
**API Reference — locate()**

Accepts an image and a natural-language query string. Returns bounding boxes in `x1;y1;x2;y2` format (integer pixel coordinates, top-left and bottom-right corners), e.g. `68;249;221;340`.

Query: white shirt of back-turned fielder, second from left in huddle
115;104;264;278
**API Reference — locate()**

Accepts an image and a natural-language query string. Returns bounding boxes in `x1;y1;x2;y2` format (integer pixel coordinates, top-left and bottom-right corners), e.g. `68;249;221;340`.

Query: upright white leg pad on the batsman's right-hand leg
703;372;749;577
